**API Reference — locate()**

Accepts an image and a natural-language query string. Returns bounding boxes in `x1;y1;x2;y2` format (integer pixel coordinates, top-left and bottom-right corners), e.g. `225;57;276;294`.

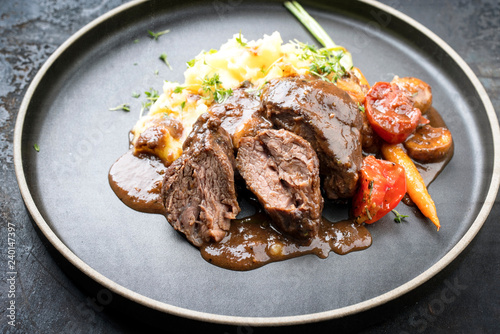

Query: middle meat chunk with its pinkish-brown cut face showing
236;130;323;239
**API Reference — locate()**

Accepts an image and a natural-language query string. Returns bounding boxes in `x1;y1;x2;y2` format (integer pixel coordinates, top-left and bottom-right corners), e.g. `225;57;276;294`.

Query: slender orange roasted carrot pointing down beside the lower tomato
382;144;441;231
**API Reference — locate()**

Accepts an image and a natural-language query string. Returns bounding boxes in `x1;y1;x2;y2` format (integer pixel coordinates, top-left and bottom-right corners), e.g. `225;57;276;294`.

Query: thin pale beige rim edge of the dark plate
13;0;500;326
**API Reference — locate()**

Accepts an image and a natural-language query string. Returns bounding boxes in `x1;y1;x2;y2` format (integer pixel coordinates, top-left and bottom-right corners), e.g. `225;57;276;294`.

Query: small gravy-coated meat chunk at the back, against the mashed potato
209;88;272;148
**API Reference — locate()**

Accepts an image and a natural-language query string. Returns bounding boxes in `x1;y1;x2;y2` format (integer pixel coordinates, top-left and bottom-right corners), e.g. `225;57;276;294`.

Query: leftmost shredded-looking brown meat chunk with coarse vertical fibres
162;113;240;246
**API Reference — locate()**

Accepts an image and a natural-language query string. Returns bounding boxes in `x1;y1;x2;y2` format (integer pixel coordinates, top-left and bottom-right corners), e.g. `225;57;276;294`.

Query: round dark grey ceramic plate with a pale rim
11;0;499;325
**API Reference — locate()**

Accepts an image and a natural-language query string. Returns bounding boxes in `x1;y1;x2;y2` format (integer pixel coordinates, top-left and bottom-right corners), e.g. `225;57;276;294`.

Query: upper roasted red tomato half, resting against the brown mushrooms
365;82;422;144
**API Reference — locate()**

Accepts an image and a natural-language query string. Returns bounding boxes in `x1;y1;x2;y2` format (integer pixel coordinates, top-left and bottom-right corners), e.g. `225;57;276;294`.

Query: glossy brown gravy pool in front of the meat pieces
200;212;372;270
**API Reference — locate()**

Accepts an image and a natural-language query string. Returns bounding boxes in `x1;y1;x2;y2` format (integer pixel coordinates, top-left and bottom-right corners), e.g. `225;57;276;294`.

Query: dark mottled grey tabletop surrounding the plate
0;0;500;334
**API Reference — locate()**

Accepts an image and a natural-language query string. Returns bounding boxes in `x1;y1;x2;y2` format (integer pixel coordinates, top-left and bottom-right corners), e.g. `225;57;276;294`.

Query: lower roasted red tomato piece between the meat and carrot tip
352;155;406;224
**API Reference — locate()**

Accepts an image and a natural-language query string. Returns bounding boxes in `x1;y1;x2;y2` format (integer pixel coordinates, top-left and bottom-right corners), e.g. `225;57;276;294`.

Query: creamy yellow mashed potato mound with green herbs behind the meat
132;32;316;164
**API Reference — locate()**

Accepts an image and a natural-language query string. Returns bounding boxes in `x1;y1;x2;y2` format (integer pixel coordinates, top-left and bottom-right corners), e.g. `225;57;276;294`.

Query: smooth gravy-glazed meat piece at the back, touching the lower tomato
261;76;362;199
